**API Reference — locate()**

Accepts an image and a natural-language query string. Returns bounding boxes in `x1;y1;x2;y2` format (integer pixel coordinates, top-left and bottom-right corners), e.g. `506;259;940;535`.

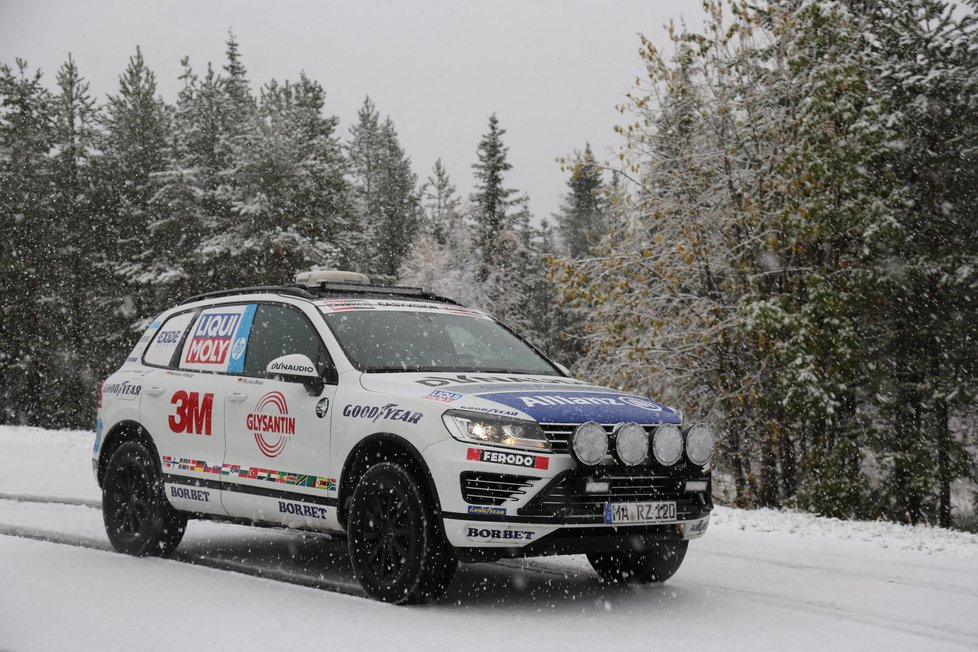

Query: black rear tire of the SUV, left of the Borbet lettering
102;441;187;557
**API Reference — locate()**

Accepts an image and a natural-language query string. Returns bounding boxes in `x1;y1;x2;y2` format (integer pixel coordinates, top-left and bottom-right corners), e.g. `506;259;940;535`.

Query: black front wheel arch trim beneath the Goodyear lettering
337;432;441;528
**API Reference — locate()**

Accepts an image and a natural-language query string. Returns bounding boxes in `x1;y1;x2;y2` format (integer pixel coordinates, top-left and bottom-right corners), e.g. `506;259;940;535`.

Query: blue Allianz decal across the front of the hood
478;391;680;424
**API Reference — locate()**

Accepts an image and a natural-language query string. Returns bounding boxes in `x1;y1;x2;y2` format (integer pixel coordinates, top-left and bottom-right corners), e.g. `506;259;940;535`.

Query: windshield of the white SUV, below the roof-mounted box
323;306;559;375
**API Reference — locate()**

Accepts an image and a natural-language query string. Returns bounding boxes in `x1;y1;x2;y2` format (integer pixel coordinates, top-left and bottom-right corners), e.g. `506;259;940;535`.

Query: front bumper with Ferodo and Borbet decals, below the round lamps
426;440;713;561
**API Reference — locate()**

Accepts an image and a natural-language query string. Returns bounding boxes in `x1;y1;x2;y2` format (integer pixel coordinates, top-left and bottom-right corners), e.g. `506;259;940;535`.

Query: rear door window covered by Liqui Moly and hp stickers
180;304;257;373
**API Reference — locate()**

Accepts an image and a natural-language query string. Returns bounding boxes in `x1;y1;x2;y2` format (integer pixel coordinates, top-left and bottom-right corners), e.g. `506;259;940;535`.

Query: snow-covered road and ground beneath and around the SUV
0;427;978;651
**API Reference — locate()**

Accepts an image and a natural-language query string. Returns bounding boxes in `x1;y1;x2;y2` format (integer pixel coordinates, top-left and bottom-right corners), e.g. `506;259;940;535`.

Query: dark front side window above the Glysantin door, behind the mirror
244;304;332;378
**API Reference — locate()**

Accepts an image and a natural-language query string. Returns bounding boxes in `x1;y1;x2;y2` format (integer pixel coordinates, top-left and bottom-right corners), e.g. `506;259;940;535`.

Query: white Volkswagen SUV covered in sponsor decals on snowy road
92;273;713;603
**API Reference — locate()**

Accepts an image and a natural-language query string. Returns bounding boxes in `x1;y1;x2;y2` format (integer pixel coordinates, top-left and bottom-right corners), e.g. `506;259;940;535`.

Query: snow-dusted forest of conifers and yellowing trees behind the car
0;0;978;527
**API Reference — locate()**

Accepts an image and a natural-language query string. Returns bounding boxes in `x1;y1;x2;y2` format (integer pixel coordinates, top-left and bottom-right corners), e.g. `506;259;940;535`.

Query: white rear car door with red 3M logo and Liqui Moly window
142;305;254;514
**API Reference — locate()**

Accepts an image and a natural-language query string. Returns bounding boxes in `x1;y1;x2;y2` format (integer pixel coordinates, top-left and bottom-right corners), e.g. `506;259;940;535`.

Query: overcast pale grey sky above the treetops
0;0;701;218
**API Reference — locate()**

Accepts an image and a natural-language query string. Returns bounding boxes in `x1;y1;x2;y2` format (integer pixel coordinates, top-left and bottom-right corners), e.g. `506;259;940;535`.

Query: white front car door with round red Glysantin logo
222;302;337;529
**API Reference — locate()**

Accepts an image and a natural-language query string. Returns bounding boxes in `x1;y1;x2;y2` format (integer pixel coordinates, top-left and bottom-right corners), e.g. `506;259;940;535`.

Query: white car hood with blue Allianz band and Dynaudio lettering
360;373;682;425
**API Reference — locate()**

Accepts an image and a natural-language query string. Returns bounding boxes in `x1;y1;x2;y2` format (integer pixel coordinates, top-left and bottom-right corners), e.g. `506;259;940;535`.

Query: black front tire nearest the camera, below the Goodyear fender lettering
347;462;458;604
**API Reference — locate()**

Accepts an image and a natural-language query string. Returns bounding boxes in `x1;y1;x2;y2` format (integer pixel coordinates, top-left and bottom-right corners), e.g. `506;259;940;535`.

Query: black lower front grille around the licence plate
519;472;712;523
